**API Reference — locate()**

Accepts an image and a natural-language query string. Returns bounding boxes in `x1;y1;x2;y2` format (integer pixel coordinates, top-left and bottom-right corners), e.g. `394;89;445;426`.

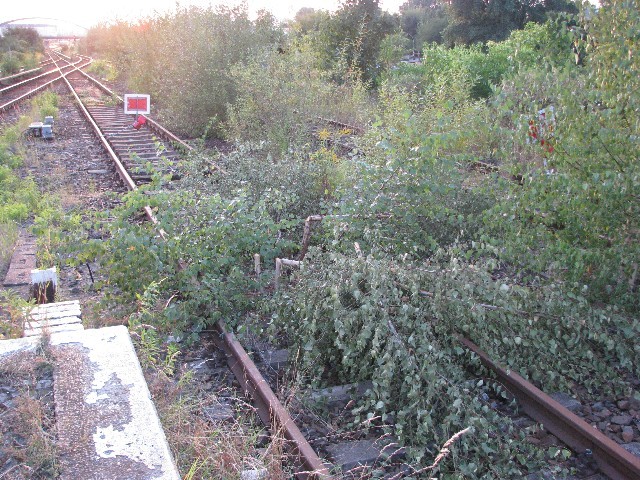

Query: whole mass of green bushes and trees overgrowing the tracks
57;0;640;478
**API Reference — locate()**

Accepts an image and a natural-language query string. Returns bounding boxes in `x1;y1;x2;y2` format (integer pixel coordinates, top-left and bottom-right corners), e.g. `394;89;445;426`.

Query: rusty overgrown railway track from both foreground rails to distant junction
0;49;640;480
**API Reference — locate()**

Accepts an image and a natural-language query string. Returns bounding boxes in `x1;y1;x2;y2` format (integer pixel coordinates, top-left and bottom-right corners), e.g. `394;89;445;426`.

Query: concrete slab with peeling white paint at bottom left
49;326;180;480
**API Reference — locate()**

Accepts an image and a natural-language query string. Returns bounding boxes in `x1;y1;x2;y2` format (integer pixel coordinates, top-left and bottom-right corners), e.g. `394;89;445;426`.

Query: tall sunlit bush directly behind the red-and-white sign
87;5;282;135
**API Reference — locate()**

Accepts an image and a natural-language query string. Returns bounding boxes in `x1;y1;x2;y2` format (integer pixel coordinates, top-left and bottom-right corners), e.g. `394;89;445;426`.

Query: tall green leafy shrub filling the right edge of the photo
486;2;640;312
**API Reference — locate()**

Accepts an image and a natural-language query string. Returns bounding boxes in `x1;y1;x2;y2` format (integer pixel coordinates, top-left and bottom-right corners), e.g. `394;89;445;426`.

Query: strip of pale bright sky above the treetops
0;0;404;31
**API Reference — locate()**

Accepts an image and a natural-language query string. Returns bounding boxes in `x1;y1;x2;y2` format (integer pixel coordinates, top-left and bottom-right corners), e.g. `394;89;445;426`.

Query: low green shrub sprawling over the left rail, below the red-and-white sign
67;158;299;340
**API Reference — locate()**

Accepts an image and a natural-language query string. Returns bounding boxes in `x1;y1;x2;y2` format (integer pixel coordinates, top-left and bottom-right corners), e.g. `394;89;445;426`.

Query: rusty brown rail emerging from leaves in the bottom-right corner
460;337;640;480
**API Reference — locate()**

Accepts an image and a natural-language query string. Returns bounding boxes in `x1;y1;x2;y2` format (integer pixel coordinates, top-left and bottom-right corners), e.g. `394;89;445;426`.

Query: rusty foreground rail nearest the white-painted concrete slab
215;321;333;480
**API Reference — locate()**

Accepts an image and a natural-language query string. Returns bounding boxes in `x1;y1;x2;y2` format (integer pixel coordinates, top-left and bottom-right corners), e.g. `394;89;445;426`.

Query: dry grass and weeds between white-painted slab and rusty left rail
129;284;286;480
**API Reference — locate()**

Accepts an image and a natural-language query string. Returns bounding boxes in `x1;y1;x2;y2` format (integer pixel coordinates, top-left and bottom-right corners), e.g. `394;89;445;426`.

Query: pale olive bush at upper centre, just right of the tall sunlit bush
224;50;371;155
